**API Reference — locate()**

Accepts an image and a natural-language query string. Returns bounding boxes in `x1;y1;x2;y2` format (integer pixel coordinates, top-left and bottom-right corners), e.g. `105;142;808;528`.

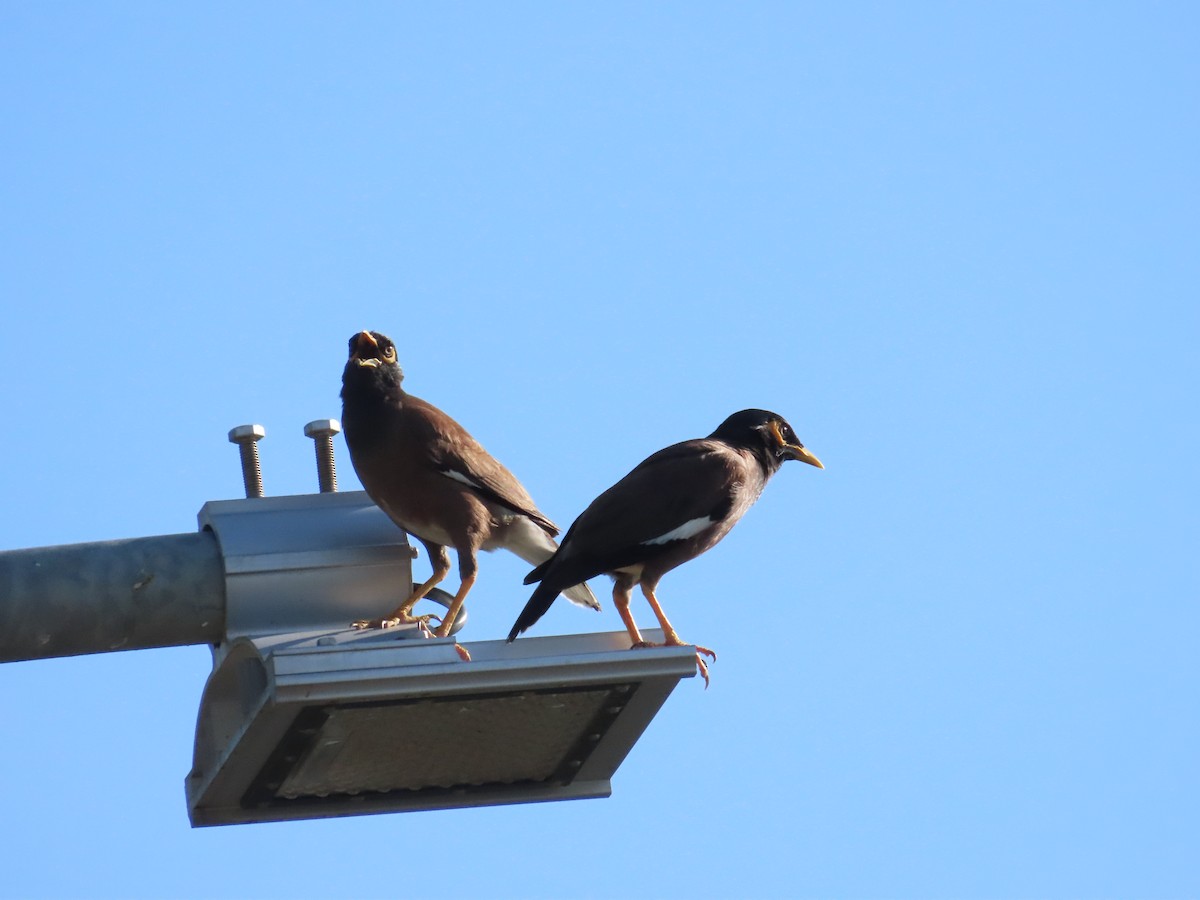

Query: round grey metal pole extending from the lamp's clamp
0;532;226;662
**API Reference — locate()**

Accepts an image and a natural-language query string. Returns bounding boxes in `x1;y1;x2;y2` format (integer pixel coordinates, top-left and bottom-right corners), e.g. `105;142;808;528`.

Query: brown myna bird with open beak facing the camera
342;331;600;659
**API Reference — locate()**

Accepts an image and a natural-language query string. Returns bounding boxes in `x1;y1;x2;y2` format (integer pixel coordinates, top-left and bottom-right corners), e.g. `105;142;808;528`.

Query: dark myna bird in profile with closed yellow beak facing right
509;409;824;686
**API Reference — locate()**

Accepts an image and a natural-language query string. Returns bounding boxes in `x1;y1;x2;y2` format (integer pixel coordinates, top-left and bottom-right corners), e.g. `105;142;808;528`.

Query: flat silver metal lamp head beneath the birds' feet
186;631;696;826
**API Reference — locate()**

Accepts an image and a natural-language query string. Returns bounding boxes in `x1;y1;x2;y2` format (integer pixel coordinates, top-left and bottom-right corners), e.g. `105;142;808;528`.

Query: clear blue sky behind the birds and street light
0;2;1200;898
